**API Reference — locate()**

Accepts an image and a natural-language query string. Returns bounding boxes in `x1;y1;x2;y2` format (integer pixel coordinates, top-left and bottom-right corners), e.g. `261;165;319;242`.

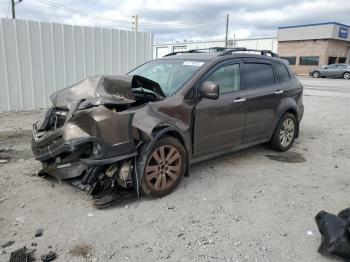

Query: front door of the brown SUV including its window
194;60;246;157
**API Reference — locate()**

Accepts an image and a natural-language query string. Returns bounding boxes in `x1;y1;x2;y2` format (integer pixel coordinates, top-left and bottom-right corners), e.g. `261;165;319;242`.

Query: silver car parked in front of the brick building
309;64;350;80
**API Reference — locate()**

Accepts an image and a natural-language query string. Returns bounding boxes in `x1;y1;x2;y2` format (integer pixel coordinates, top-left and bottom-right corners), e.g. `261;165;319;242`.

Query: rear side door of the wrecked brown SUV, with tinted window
243;58;290;144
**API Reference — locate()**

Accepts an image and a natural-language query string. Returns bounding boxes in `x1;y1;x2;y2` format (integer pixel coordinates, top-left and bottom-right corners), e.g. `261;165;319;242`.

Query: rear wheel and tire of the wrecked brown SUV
270;113;298;152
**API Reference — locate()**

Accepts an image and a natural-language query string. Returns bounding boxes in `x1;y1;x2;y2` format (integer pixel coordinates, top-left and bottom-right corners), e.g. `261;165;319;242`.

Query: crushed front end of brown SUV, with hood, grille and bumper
32;76;165;206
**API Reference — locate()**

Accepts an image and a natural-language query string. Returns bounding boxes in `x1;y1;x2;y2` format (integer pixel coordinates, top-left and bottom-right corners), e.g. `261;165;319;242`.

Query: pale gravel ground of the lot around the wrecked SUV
0;78;350;262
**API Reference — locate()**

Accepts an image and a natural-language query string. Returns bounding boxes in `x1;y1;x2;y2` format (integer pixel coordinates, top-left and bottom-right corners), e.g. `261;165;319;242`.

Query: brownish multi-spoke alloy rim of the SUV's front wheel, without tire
145;145;181;191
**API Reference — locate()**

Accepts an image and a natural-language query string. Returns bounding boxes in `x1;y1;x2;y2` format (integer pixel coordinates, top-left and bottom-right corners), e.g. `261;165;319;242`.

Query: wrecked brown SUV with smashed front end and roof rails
32;48;303;207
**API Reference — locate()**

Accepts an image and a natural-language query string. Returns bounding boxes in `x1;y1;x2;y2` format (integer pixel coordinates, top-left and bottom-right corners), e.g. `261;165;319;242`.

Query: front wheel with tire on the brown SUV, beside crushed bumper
141;136;187;197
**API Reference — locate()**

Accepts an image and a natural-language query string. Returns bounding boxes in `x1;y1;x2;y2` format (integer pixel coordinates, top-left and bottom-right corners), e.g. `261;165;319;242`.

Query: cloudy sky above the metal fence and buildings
0;0;350;43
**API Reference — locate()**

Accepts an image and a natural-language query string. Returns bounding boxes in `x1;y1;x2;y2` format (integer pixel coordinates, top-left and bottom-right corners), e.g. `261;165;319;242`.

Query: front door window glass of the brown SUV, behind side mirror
206;64;241;94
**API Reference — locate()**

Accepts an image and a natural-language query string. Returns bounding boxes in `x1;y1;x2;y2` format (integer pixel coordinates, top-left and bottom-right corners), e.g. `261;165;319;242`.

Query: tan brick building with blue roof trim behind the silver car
277;22;350;74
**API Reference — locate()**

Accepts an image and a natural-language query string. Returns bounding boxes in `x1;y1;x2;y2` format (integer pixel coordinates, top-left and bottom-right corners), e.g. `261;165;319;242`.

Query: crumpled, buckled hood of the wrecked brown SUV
51;75;165;108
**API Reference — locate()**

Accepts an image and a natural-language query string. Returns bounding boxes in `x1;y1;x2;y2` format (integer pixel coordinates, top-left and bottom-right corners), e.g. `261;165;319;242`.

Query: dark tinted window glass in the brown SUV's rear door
244;63;275;89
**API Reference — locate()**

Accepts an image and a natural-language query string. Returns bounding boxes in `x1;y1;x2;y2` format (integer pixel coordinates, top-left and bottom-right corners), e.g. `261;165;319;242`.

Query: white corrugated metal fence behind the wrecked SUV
0;19;153;111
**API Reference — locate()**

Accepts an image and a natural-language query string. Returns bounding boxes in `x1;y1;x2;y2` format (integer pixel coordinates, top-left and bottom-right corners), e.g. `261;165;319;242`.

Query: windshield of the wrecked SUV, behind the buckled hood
129;60;204;96
